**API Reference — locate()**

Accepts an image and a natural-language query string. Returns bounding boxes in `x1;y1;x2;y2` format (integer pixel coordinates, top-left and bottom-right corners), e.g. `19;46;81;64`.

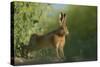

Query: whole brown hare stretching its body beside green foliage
24;12;69;58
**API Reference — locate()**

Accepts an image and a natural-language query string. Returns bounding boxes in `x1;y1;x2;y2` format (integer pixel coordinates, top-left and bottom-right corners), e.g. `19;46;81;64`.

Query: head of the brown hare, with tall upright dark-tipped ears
59;12;69;35
